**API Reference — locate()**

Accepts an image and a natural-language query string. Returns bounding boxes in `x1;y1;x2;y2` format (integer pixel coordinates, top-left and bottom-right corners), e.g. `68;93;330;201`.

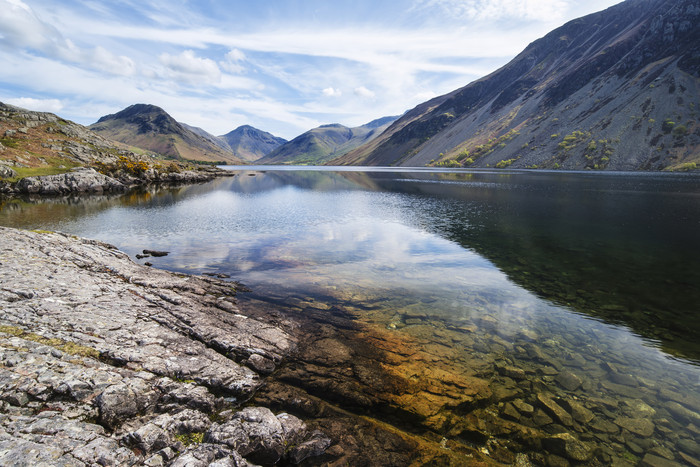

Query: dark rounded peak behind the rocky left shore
89;104;242;164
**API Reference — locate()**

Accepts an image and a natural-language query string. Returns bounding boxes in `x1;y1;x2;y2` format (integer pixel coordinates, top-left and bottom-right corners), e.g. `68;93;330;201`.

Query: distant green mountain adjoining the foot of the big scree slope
257;117;398;165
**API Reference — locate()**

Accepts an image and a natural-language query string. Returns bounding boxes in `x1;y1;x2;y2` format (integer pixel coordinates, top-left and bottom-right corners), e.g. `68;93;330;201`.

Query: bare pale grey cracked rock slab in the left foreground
0;227;331;466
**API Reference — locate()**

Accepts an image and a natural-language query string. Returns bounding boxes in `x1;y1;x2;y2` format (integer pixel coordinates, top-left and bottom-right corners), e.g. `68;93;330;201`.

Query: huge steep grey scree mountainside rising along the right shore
331;0;700;170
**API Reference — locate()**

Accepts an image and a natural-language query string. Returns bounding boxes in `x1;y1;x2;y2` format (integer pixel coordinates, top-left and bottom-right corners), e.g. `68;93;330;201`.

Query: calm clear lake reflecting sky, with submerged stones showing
0;167;700;465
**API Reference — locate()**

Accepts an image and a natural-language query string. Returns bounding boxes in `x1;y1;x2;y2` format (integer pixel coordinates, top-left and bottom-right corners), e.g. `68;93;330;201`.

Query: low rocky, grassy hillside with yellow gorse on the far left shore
0;103;221;194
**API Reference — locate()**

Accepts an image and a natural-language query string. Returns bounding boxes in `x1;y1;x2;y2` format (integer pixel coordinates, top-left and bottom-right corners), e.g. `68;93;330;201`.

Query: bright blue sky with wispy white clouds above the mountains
0;0;620;139
